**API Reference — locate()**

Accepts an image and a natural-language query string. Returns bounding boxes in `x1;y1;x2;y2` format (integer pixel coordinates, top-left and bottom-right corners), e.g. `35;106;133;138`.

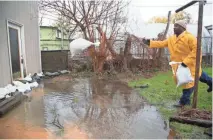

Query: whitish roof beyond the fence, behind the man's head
128;23;210;38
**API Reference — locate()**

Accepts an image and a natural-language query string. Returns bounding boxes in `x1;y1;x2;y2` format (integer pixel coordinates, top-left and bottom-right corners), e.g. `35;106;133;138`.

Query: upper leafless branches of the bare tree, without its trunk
40;0;128;41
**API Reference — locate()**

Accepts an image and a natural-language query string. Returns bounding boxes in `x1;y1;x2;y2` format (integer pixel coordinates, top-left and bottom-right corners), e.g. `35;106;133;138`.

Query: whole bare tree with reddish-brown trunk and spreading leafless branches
40;0;129;72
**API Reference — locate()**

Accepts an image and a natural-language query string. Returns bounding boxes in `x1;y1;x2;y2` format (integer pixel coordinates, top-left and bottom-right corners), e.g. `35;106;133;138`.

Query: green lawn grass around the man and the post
129;67;212;138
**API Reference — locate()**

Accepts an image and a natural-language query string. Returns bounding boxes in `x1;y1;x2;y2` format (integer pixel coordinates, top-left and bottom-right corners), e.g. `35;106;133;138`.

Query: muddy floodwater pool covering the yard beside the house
0;79;169;139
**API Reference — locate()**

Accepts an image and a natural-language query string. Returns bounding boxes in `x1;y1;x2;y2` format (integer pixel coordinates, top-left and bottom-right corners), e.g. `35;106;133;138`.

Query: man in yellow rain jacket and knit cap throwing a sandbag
143;20;212;106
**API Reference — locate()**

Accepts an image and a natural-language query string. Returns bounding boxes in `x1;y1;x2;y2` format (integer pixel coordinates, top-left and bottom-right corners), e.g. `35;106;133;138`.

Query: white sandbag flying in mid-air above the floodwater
70;38;100;57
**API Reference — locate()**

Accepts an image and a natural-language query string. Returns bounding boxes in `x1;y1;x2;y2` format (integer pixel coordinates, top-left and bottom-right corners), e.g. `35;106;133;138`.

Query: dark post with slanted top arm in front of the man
175;0;206;108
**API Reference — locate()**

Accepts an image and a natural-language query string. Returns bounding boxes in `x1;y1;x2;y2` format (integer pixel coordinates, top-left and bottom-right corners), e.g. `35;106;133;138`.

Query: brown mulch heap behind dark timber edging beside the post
178;109;212;120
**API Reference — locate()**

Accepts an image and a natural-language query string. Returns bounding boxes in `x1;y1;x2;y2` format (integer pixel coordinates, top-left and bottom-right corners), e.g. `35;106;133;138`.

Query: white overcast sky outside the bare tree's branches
40;0;213;25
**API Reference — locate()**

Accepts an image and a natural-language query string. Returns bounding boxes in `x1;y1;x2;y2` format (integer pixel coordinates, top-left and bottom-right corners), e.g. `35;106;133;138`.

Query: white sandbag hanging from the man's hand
169;61;194;87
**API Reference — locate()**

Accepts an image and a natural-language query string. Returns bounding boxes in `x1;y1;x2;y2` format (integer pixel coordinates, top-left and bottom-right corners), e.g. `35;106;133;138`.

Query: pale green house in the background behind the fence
40;26;69;50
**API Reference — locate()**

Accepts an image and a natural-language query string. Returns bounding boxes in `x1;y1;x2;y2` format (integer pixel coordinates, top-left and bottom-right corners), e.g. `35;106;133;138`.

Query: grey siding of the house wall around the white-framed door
0;1;41;87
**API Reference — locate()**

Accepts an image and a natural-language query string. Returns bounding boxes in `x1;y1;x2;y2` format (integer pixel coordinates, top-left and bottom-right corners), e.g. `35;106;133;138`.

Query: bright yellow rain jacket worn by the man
150;31;202;89
